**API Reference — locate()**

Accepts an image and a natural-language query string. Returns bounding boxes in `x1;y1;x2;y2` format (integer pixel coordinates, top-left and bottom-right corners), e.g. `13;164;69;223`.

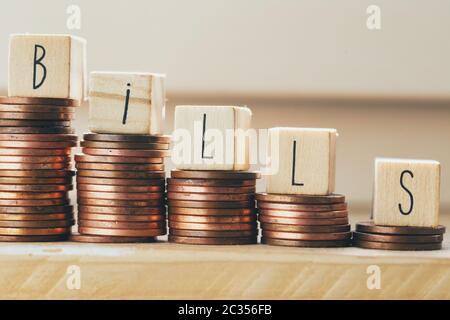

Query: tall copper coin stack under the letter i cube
72;133;170;243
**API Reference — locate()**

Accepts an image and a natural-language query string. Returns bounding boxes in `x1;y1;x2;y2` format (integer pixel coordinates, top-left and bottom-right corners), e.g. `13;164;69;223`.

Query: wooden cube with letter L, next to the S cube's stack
267;128;337;195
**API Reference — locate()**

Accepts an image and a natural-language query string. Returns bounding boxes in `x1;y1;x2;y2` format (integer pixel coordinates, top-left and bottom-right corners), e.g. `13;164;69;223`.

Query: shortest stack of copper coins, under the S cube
353;221;445;251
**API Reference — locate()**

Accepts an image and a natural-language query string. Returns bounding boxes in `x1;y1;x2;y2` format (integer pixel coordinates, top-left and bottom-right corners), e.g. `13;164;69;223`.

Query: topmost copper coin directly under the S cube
356;221;445;235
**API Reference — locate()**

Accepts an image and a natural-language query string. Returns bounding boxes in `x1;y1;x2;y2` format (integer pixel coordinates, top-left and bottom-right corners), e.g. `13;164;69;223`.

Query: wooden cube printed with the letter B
8;34;86;100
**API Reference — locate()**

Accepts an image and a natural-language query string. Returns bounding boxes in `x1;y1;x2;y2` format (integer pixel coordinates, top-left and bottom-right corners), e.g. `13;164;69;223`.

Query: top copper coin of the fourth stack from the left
256;193;345;204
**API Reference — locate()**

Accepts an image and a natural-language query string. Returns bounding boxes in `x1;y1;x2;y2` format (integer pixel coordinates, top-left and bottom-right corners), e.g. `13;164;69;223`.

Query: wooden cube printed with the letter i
89;72;166;134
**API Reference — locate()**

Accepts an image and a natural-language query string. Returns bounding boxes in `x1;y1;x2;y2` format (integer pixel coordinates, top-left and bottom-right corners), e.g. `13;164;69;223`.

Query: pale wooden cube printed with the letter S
373;158;440;227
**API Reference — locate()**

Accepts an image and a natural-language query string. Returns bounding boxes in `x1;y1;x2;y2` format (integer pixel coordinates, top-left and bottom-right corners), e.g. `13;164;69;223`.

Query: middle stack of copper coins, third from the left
167;170;259;245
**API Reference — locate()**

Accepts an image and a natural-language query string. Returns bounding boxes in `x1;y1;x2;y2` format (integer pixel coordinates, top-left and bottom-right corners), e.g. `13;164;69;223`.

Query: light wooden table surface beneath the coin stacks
0;215;450;299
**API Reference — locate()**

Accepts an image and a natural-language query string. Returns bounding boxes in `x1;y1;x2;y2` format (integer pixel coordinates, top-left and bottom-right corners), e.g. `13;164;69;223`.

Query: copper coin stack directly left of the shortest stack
256;193;351;247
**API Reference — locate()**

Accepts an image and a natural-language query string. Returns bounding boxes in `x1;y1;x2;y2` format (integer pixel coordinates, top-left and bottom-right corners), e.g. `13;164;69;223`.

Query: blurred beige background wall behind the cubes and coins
0;0;450;214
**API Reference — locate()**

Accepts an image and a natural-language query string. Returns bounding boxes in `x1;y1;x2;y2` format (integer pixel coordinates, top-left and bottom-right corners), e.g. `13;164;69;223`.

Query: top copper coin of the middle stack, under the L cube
170;170;261;180
